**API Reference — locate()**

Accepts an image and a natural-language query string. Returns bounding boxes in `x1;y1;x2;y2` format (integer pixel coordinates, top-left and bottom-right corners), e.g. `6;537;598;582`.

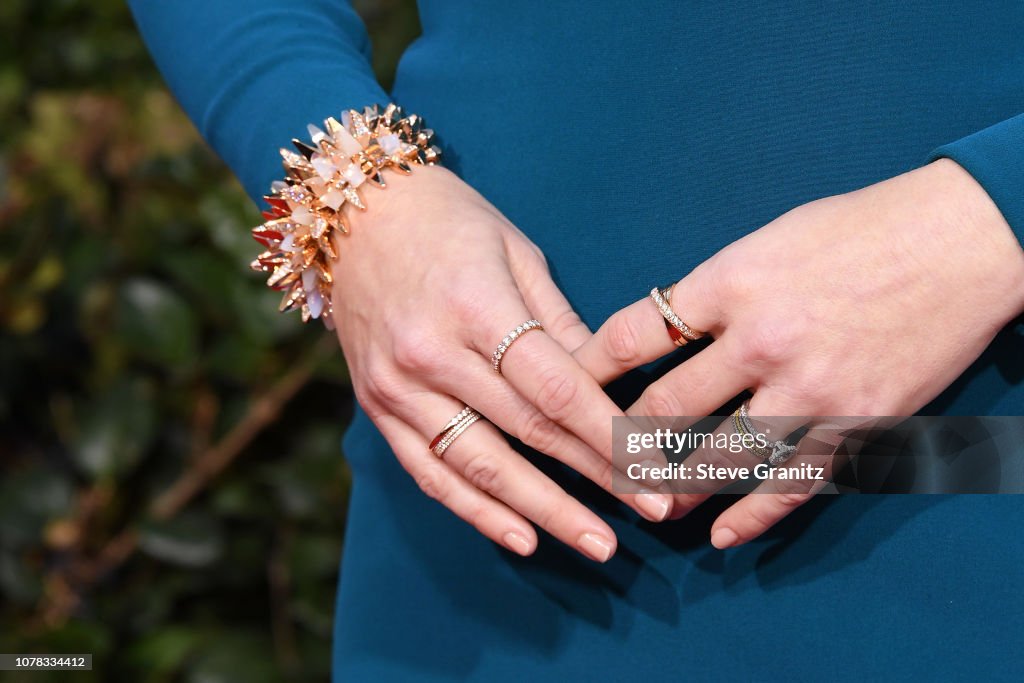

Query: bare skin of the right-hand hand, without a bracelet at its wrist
574;160;1024;548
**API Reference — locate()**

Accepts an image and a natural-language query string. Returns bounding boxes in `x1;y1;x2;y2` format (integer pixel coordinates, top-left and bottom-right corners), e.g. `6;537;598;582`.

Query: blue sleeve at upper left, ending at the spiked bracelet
123;0;388;200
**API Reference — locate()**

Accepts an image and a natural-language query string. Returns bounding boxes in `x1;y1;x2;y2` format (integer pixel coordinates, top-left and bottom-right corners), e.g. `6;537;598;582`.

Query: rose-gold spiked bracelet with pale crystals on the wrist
252;104;440;330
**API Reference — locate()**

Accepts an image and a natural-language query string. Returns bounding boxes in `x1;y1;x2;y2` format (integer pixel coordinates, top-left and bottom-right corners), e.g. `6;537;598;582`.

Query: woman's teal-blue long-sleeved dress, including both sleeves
132;0;1024;681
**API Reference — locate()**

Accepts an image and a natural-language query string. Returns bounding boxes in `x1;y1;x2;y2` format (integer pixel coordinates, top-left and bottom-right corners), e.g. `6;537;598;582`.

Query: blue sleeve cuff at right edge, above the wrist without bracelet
929;114;1024;245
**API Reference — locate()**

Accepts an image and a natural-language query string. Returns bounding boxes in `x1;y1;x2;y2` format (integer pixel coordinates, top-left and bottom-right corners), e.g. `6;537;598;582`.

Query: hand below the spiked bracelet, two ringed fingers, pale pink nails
333;166;671;562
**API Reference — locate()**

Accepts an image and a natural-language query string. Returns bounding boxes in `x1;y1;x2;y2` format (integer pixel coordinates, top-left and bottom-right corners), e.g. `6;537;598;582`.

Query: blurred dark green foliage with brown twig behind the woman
0;0;419;683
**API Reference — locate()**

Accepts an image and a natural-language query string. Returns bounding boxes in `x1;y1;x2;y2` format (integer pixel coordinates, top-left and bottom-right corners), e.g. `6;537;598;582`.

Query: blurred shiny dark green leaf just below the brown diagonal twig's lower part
138;512;224;567
